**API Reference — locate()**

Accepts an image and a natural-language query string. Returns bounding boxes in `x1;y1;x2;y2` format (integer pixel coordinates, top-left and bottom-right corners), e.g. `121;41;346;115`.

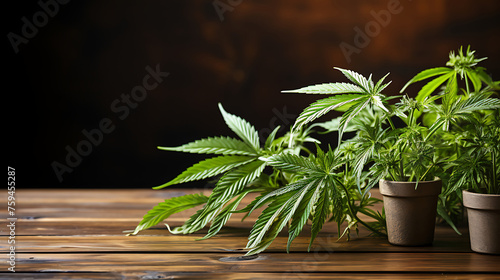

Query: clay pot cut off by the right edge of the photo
462;191;500;254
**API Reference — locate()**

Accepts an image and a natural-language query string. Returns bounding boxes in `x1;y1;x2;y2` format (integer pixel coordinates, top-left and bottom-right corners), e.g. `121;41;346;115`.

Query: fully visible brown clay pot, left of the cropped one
379;178;442;246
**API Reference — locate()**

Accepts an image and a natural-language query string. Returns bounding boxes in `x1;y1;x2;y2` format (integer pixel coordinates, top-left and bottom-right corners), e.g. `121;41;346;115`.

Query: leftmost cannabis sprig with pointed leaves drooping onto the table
132;104;301;238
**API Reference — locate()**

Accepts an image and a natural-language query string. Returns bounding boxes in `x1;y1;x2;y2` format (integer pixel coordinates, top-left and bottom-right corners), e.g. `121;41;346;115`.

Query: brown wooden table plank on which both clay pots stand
5;227;471;255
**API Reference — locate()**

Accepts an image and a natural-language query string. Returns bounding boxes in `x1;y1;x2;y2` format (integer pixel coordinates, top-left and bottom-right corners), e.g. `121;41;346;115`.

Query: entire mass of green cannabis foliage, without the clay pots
132;45;500;255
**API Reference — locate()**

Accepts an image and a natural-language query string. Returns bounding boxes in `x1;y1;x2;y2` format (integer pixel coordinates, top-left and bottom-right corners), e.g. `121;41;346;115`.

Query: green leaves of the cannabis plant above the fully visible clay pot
285;68;440;187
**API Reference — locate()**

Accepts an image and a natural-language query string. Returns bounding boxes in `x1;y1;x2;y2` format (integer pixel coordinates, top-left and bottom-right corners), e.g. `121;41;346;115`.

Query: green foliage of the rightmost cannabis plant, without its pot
402;47;500;225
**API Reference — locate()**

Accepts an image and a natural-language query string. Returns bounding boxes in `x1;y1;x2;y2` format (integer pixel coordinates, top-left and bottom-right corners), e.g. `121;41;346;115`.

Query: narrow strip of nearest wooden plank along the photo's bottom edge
4;271;499;280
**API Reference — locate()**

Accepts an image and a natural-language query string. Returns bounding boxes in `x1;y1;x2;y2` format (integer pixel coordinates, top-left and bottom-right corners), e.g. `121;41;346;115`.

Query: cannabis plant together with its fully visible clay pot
286;68;441;245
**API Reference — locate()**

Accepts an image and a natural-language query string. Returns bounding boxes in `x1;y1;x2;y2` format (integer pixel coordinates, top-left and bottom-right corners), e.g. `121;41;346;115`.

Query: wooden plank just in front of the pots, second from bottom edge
11;252;500;274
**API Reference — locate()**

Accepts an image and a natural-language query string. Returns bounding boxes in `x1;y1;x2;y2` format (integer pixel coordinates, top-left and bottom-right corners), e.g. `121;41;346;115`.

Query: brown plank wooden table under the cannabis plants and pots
0;189;500;280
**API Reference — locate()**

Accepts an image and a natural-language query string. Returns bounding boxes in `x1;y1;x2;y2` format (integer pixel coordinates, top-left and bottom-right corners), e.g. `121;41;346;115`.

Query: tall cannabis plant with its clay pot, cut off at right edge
398;47;500;254
